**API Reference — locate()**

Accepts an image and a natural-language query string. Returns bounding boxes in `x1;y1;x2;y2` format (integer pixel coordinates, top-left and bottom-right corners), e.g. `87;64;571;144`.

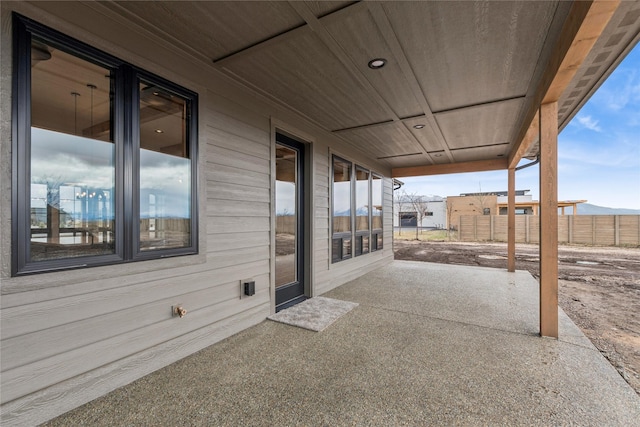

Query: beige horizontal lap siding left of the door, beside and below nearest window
1;62;271;418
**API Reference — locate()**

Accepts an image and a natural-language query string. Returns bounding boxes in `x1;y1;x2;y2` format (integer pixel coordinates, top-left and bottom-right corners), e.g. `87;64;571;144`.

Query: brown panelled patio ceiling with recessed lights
106;1;640;176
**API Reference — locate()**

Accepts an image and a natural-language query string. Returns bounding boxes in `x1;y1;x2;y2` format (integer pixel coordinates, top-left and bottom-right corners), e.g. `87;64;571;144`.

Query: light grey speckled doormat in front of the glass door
268;297;358;332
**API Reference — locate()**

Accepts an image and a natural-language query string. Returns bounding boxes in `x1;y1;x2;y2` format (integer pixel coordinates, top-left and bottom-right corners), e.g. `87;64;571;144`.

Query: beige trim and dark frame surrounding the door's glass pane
270;123;314;313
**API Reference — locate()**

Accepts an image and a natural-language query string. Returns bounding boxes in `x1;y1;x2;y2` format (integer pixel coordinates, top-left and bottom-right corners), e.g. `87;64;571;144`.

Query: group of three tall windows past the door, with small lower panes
331;156;383;262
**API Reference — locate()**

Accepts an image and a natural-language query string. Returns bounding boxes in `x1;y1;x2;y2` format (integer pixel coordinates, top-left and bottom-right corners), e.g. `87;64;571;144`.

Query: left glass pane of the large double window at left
30;40;115;261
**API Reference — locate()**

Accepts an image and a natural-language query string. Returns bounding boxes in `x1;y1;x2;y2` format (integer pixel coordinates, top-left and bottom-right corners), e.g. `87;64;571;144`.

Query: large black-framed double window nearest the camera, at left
12;15;197;274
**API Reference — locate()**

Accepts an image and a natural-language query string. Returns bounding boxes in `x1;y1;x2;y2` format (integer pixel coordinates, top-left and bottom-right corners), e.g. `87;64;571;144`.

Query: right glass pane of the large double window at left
140;82;191;251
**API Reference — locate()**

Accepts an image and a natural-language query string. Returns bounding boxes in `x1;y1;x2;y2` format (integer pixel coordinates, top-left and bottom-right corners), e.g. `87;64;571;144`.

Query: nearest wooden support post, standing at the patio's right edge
540;102;558;338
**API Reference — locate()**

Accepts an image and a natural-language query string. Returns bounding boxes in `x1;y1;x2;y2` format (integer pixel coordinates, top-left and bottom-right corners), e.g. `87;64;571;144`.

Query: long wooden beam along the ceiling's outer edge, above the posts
509;0;620;170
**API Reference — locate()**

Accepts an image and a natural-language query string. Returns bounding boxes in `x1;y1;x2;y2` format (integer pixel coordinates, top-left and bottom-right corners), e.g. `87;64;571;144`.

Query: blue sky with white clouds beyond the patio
401;44;640;209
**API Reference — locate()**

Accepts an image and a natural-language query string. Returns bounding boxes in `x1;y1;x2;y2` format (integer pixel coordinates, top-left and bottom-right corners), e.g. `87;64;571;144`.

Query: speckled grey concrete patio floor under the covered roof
48;261;640;426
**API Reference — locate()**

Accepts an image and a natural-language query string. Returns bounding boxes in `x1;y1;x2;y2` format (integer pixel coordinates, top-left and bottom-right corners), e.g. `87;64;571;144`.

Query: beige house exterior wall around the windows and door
0;2;393;426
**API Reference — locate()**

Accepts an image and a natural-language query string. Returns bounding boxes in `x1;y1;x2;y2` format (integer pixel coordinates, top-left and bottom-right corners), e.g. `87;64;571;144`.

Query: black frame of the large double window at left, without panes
11;13;198;276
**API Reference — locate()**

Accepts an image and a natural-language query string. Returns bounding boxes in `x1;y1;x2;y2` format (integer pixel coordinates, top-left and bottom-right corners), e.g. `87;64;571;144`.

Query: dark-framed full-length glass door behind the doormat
275;134;306;311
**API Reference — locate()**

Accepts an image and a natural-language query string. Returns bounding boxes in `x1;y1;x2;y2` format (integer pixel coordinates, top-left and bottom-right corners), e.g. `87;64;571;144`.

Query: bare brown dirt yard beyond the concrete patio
394;239;640;394
